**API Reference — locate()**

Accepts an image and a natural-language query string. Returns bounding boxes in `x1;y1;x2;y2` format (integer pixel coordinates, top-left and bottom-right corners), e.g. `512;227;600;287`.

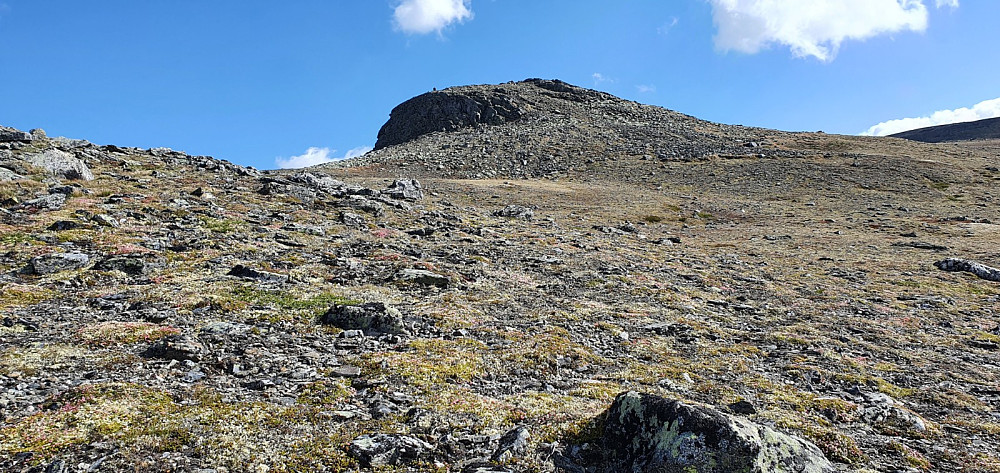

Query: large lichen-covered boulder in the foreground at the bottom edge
598;392;835;473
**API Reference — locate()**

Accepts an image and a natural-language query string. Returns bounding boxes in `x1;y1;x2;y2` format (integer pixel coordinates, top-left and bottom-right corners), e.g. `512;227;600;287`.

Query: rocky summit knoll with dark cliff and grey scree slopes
336;79;796;180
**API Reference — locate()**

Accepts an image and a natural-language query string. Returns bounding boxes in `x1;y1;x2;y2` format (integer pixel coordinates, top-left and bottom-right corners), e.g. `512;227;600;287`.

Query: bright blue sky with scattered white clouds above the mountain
0;0;1000;169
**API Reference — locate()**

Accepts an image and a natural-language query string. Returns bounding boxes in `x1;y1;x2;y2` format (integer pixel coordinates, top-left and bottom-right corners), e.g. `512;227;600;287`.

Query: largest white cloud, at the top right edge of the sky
709;0;958;61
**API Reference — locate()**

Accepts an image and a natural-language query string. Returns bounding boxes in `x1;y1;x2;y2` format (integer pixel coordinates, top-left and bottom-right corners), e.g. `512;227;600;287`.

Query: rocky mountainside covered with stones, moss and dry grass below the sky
0;81;1000;473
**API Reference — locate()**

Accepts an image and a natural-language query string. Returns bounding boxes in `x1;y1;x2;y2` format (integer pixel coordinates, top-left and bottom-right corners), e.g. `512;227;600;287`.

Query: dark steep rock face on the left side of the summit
375;89;522;149
